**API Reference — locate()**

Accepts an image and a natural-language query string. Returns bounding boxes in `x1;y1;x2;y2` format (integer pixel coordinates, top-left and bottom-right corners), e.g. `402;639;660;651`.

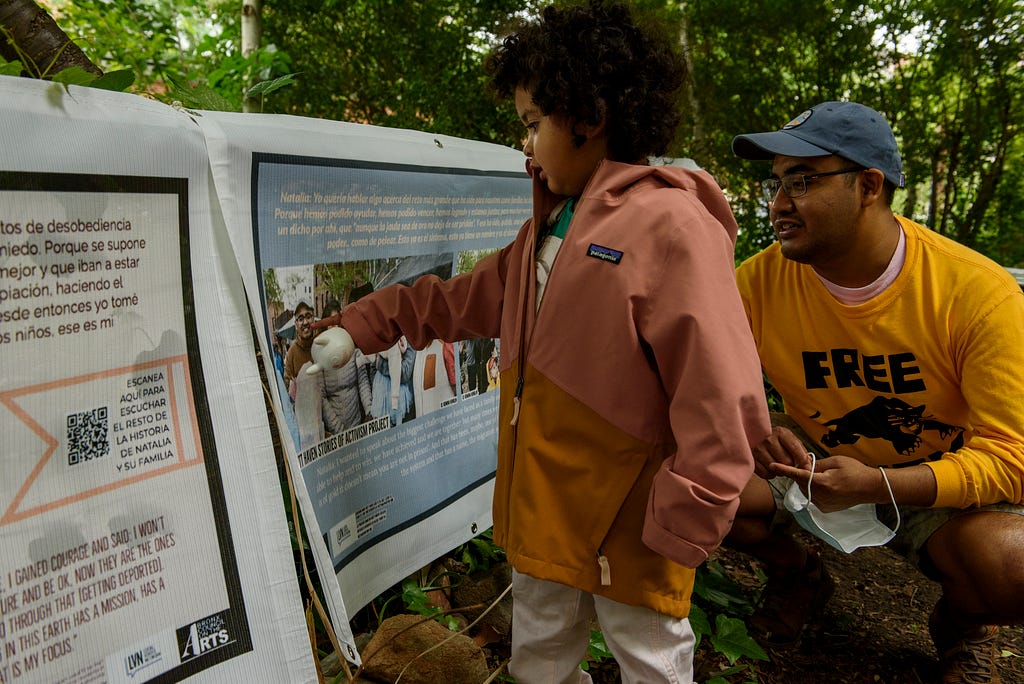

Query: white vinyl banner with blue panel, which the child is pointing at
198;112;530;657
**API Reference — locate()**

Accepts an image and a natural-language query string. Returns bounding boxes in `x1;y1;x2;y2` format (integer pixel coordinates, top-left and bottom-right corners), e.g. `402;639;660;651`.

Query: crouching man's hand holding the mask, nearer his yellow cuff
769;456;890;513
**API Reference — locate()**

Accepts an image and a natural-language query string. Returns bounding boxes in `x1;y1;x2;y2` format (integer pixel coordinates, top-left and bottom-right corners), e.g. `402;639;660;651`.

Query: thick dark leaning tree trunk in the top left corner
0;0;103;79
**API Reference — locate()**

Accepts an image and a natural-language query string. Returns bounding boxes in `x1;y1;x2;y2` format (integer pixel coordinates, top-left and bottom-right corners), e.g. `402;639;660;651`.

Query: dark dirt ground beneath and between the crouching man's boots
592;538;1024;684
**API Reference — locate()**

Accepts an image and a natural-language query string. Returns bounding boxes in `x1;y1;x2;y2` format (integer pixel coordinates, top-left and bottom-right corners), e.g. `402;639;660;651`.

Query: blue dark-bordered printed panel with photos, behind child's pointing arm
253;153;531;597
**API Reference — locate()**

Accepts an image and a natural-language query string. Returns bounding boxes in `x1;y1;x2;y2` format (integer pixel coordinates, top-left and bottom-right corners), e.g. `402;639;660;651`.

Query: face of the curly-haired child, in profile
515;88;607;197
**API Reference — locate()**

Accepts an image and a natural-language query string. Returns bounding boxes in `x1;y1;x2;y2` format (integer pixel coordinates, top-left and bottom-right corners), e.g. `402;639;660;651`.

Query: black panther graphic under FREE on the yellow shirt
812;396;964;458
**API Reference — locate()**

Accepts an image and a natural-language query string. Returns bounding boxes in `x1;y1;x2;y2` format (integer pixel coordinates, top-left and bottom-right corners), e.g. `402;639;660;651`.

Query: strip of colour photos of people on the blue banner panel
263;250;498;452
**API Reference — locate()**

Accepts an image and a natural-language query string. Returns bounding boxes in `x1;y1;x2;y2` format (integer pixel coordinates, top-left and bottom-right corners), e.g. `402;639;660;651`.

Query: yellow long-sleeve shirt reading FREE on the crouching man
737;217;1024;508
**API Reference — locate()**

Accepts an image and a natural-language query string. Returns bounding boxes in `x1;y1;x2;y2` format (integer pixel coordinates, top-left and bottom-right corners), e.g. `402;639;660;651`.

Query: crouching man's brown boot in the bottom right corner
928;605;1002;684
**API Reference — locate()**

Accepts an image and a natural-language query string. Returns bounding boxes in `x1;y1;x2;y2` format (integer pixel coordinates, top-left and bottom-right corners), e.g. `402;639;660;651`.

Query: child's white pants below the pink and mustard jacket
509;571;696;684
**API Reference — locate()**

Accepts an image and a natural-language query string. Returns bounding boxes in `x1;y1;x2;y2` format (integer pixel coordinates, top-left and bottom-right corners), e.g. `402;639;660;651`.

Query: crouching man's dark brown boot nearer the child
749;549;836;648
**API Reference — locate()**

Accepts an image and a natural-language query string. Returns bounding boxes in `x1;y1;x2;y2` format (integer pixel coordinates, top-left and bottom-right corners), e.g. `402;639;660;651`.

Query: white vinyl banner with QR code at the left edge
0;77;316;684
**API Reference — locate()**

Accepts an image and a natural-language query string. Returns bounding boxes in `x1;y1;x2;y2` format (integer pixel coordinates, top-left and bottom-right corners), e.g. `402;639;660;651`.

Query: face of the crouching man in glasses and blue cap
769;156;860;266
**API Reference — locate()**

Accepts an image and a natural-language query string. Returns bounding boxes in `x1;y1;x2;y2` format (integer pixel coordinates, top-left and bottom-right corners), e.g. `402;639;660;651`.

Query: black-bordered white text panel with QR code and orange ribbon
0;171;253;683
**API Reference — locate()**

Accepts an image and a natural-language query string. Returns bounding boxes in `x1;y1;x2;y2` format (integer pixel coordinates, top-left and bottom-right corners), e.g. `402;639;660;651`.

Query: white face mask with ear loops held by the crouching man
782;454;900;553
